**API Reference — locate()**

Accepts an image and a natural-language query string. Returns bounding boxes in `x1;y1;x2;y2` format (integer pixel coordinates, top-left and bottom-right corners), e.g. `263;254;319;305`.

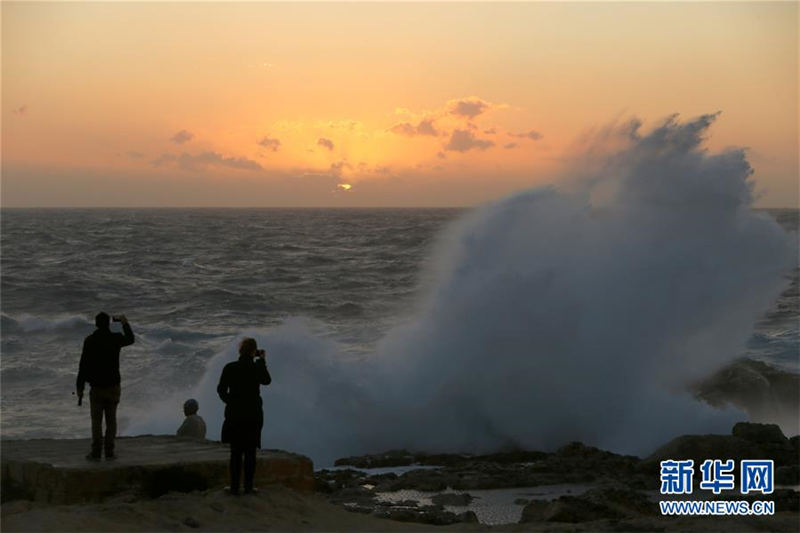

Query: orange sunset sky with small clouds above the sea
0;2;798;206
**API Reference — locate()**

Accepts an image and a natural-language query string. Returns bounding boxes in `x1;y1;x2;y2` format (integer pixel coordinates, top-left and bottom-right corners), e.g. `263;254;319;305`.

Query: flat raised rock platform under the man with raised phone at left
0;435;314;504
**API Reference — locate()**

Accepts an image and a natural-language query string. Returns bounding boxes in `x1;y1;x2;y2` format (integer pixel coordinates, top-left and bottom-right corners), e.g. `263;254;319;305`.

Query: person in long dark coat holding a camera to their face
217;338;272;494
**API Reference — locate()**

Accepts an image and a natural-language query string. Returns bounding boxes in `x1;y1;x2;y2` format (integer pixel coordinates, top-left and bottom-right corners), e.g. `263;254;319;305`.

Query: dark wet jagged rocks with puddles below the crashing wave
316;422;800;524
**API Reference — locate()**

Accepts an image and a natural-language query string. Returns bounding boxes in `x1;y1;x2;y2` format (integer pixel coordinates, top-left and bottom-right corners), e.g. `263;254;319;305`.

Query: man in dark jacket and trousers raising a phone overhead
76;312;133;460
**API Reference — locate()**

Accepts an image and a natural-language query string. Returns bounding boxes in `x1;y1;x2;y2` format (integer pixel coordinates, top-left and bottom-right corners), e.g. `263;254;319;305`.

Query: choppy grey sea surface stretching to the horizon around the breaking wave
0;209;800;438
